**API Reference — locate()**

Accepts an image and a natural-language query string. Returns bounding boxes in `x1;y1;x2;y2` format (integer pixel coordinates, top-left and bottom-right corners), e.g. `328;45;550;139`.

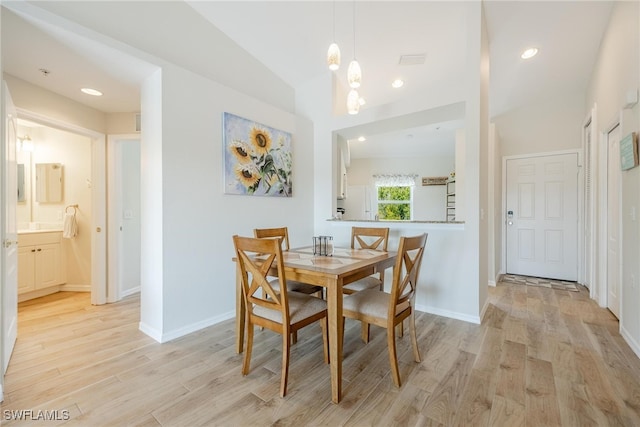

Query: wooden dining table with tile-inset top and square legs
236;246;396;403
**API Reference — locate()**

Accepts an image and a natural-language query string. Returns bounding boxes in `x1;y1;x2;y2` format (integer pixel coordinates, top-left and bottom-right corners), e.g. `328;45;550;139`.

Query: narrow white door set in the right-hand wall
607;126;622;318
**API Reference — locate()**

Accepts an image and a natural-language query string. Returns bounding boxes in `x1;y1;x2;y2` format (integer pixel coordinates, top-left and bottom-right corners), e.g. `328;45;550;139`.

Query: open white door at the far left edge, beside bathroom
0;82;18;376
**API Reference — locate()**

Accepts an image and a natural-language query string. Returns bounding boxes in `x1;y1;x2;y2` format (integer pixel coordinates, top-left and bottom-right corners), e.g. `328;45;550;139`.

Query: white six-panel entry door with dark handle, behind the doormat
506;153;578;281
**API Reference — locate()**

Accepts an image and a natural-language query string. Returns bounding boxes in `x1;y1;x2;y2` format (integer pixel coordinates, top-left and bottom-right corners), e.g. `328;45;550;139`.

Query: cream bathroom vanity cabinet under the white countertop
18;231;66;300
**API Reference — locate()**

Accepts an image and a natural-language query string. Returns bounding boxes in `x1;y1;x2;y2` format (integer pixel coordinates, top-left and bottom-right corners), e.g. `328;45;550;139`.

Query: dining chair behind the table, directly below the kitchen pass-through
342;227;389;294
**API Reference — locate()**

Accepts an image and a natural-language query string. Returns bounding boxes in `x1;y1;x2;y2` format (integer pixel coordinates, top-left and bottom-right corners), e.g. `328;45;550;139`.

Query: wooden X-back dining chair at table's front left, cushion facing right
233;236;329;397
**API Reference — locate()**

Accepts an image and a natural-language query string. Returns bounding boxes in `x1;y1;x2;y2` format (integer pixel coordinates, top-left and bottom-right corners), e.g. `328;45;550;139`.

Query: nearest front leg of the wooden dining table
327;280;344;403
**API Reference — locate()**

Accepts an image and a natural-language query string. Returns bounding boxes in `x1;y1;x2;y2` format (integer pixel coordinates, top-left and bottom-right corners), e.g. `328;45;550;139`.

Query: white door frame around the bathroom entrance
16;108;107;305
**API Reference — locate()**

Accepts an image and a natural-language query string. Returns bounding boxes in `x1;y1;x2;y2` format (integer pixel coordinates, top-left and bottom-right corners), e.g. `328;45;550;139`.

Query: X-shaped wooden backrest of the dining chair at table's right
388;233;427;319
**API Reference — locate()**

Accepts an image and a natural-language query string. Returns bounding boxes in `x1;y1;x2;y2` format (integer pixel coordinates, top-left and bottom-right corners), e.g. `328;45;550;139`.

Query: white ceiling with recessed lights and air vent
1;0;612;157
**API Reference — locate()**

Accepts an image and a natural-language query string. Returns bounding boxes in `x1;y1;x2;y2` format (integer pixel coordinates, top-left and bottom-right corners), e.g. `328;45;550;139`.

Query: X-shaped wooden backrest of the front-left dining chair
233;236;289;323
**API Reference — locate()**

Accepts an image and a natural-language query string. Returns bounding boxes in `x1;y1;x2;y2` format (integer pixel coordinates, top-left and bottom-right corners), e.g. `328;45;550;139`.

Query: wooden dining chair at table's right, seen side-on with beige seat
342;233;427;387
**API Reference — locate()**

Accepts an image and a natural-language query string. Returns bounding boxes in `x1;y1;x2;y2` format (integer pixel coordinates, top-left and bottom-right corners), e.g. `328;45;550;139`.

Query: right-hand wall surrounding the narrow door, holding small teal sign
585;2;640;356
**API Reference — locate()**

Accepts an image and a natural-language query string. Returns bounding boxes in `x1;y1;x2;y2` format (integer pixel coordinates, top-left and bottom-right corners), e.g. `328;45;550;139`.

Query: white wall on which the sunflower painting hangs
141;64;313;341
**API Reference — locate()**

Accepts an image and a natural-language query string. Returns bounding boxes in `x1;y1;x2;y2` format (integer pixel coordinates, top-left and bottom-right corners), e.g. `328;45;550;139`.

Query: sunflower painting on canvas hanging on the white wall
223;113;291;197
